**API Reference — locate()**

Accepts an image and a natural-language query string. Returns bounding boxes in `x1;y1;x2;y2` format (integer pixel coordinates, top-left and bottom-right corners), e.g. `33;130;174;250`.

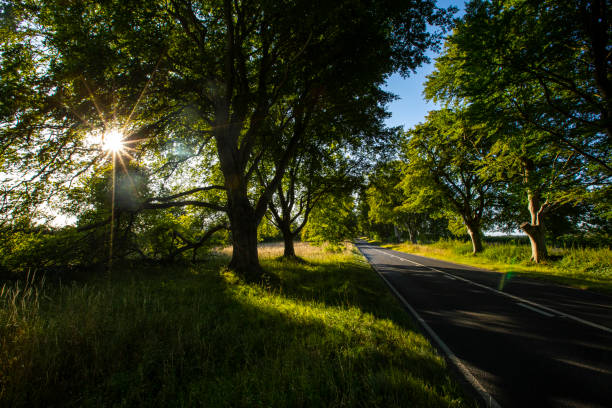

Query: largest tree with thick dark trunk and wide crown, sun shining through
3;0;448;279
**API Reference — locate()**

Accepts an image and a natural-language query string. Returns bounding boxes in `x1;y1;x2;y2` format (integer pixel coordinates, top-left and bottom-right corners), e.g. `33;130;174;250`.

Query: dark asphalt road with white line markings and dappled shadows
357;241;612;408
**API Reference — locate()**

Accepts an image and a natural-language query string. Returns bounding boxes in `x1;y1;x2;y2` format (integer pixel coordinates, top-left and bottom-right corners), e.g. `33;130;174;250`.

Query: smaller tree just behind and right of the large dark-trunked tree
261;89;396;257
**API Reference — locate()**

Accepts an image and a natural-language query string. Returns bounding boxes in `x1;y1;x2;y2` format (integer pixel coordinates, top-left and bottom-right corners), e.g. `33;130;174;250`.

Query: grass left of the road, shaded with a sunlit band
0;244;474;407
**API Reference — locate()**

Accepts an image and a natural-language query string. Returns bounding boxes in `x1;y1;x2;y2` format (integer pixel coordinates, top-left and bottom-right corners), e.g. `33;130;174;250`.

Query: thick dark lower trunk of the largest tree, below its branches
228;197;263;282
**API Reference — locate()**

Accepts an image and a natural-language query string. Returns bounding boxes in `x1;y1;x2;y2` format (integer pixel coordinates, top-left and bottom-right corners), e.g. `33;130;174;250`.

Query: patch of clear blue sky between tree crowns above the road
385;0;464;130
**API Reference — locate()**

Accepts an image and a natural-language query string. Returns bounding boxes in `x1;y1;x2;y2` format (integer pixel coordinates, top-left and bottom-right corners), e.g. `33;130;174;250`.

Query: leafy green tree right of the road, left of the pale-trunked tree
402;110;495;253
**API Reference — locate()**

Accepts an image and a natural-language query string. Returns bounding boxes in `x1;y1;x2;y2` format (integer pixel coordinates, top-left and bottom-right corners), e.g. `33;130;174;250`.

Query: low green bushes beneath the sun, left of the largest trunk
0;159;228;279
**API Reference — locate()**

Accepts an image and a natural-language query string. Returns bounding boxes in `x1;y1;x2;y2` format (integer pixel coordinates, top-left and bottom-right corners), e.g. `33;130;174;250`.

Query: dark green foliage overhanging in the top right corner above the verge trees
426;0;612;176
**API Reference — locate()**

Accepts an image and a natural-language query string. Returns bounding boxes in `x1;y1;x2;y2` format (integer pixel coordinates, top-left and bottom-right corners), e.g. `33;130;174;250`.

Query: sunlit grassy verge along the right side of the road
383;240;612;294
